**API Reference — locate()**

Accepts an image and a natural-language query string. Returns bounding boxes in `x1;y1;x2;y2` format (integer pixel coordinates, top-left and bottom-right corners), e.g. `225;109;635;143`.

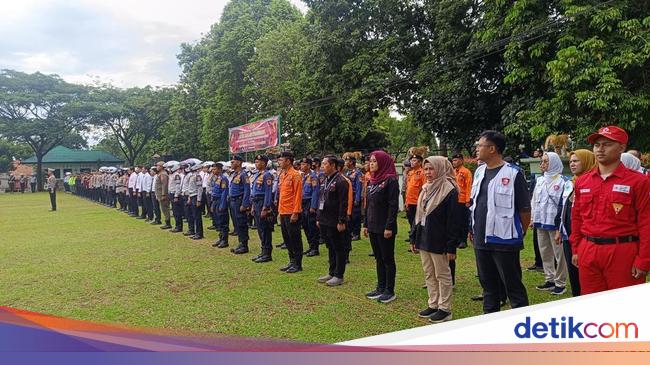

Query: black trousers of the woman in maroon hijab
368;232;397;293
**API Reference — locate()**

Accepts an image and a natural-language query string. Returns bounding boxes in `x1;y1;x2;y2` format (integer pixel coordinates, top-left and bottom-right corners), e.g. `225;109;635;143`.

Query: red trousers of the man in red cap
578;239;646;295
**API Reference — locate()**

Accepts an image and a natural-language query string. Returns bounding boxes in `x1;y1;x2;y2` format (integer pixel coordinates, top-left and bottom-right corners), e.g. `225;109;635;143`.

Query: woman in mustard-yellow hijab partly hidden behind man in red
555;150;596;297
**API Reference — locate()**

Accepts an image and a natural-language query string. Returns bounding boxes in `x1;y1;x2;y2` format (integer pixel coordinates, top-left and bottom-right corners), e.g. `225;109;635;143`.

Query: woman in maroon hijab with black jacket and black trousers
363;151;399;303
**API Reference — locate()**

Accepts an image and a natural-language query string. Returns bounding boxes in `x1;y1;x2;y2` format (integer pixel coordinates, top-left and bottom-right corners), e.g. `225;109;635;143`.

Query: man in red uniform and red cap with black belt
570;126;650;294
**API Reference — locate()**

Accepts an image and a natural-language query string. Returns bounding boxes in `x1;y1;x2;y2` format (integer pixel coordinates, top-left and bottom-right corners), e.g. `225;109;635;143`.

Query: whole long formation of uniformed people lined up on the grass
58;126;650;323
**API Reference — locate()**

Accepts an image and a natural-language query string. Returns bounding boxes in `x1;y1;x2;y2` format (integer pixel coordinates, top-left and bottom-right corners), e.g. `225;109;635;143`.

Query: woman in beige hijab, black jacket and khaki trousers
411;156;465;323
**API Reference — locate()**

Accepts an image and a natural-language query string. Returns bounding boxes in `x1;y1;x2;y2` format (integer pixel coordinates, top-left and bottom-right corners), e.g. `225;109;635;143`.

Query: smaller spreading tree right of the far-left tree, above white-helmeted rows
93;87;173;165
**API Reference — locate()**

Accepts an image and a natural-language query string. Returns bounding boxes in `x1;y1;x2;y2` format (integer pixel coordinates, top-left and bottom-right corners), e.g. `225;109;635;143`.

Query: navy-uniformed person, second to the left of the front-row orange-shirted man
228;170;251;247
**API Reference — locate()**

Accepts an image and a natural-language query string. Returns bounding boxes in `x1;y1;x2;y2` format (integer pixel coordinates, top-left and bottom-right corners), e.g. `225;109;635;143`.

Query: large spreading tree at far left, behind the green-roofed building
0;70;90;189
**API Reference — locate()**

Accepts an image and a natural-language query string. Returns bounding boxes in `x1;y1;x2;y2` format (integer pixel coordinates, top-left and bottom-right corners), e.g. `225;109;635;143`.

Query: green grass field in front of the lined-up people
0;193;570;343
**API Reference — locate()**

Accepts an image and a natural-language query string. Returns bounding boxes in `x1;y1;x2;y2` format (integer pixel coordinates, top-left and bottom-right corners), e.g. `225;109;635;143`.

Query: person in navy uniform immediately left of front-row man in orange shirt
251;170;273;256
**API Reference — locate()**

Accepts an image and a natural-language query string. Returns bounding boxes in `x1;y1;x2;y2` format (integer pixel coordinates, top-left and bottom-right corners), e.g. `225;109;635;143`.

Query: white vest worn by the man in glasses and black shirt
470;164;523;245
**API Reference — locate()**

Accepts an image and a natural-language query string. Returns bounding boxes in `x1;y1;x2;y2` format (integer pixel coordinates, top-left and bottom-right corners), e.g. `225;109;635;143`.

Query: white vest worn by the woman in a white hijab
531;175;573;231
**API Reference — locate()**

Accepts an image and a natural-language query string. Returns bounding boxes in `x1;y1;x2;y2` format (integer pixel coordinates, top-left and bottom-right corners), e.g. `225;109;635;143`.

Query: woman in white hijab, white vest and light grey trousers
531;152;573;295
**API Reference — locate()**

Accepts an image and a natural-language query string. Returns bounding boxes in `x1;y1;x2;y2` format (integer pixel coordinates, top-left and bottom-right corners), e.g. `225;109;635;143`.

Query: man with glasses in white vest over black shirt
470;131;530;313
